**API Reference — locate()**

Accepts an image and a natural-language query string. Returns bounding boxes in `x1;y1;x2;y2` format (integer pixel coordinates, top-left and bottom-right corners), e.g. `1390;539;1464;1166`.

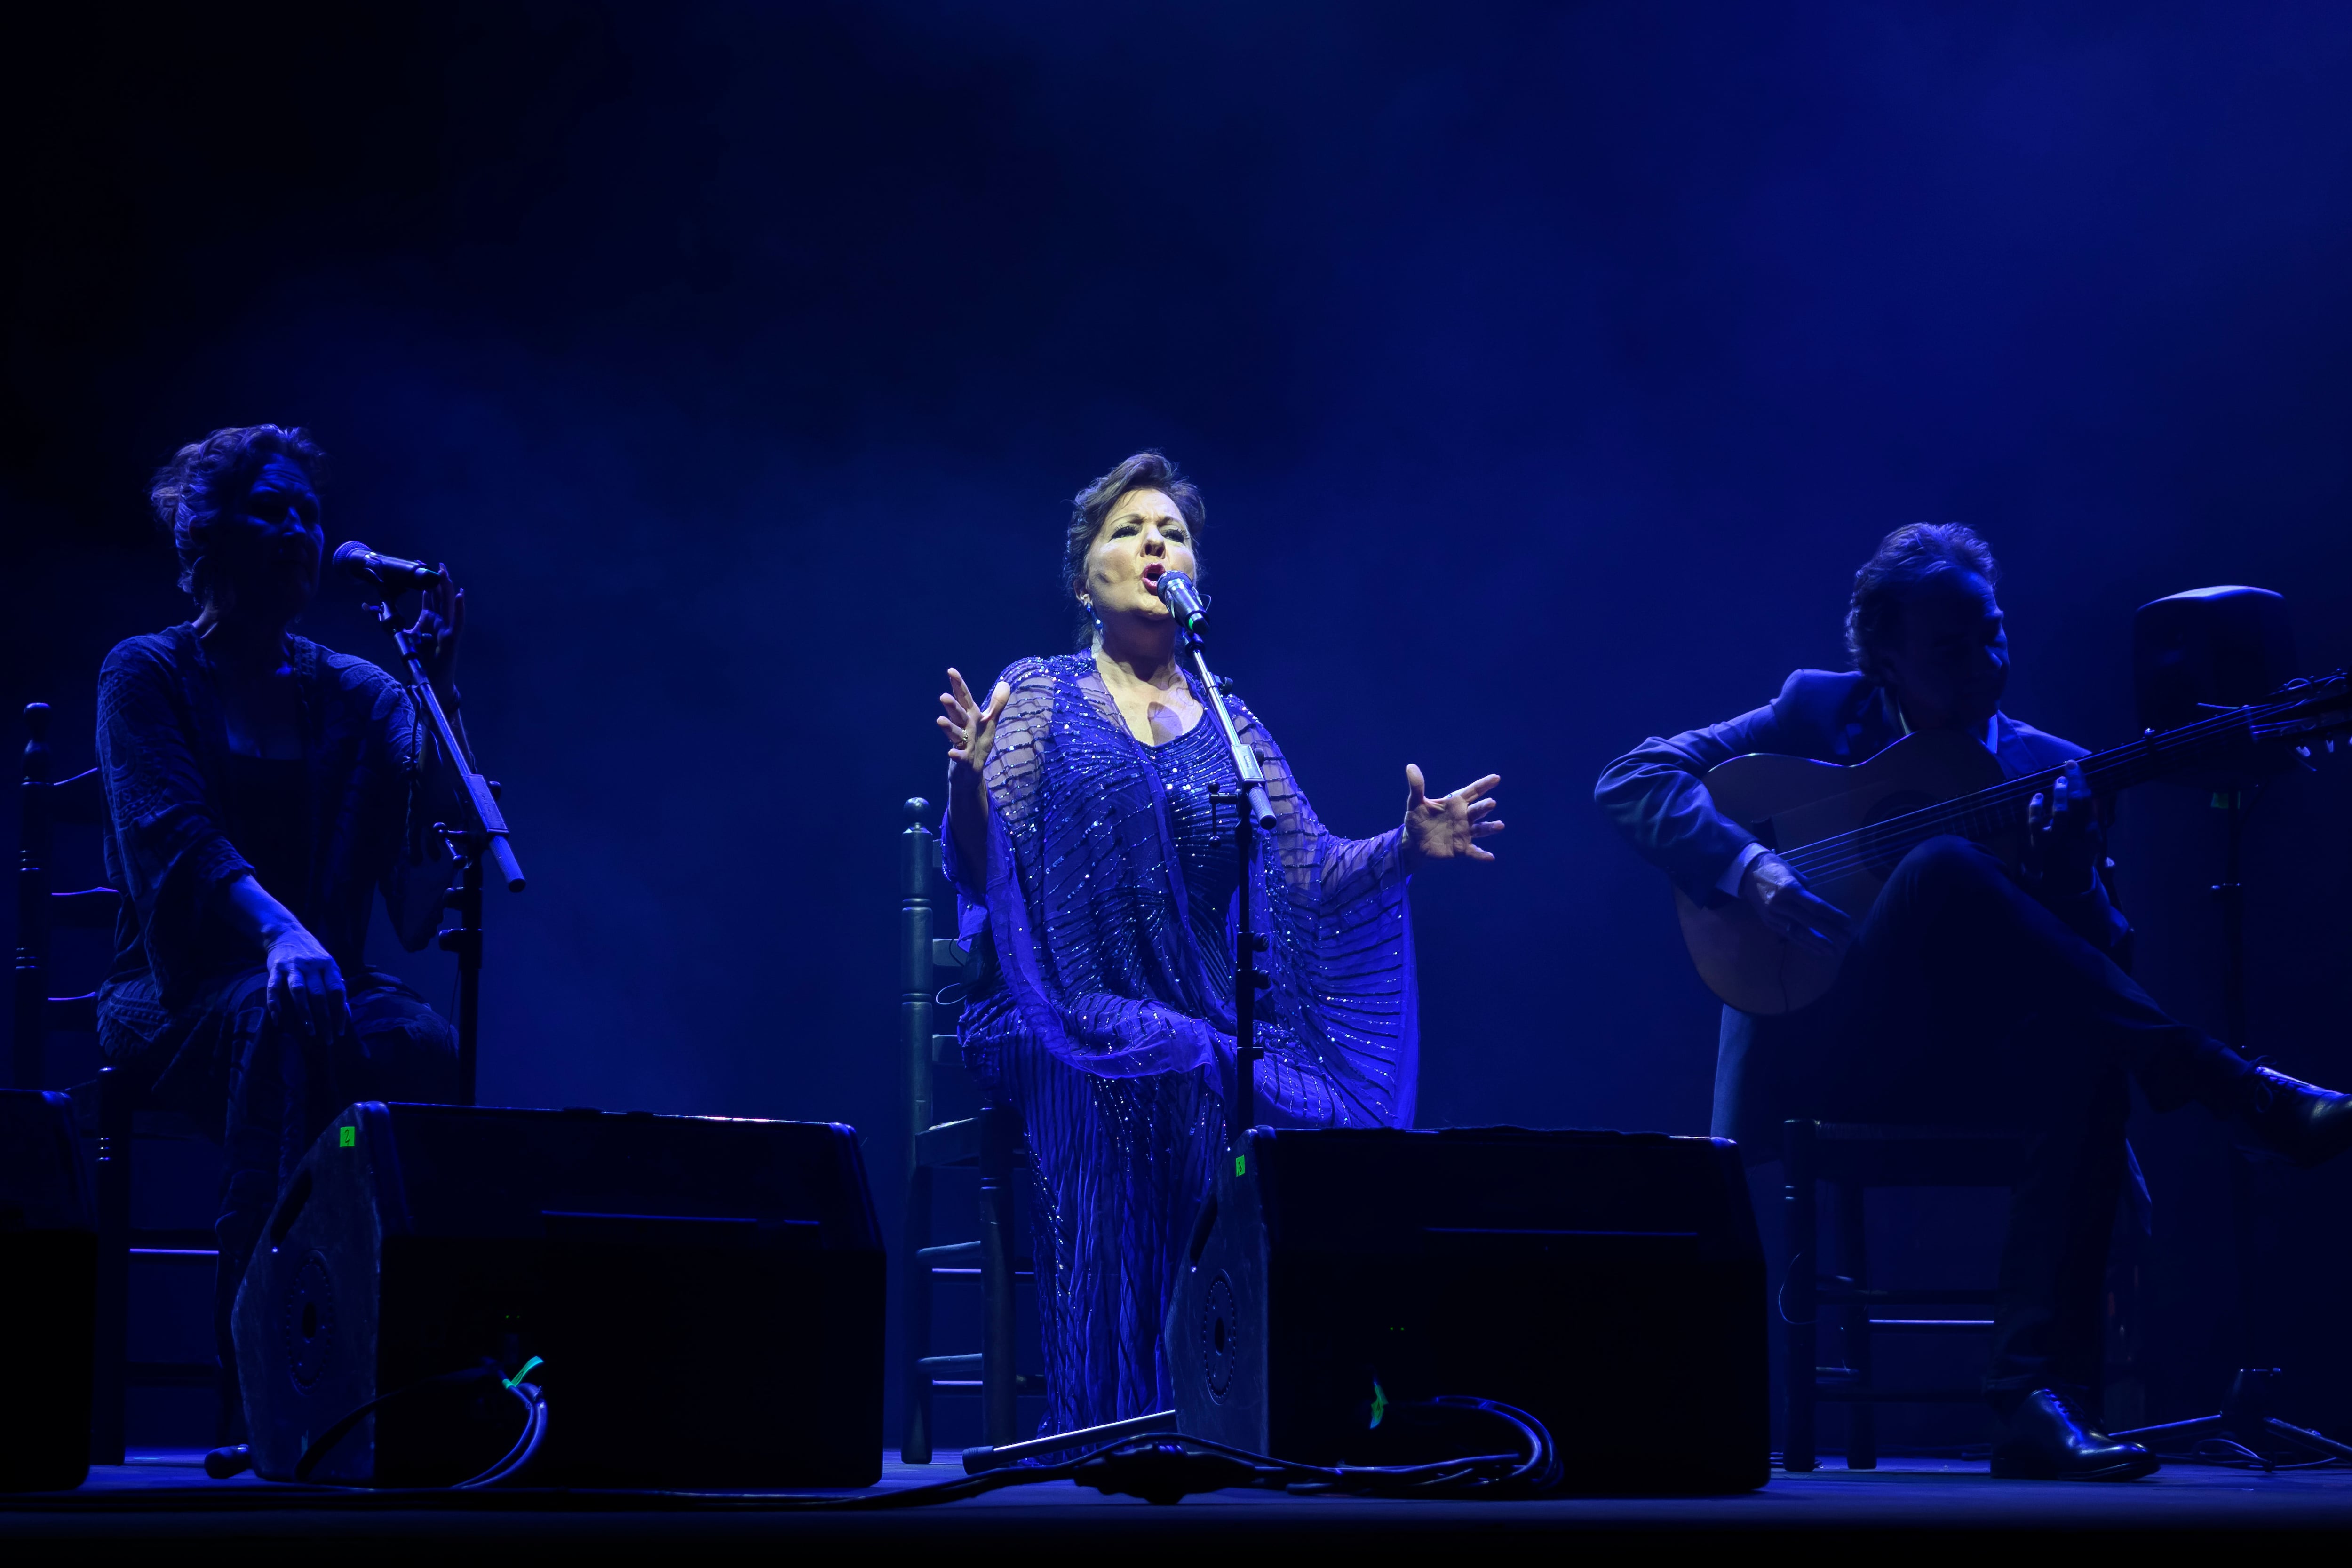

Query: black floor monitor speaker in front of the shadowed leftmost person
233;1103;884;1490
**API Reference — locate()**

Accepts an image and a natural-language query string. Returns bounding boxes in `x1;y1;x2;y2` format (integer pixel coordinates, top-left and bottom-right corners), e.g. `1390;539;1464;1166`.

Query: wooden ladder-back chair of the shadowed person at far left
9;703;228;1465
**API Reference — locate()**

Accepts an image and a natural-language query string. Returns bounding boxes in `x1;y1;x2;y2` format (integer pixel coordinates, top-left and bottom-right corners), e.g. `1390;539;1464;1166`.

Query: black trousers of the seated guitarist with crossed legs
1783;837;2251;1394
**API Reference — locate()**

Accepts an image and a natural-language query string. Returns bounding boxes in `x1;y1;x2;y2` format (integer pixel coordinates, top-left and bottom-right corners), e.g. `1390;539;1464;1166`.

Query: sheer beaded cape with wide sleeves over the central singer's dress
943;658;1418;1126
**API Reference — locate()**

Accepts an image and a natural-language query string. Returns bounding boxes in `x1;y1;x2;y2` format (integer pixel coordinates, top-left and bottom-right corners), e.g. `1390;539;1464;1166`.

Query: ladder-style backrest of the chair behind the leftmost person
9;703;122;1089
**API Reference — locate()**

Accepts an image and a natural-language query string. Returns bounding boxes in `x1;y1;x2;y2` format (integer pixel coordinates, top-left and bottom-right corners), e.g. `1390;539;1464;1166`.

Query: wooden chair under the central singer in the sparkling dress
898;799;1044;1465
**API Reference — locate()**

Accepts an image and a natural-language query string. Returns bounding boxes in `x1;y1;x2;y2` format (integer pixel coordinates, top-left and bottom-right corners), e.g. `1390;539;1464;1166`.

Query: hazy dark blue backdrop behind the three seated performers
0;2;2352;1427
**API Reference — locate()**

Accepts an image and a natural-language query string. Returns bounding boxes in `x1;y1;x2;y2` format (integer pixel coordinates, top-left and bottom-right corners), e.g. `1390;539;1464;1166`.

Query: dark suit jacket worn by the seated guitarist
1592;670;2131;1162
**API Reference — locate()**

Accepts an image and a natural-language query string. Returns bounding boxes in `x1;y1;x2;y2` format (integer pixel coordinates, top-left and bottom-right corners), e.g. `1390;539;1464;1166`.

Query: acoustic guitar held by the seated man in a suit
1675;672;2352;1013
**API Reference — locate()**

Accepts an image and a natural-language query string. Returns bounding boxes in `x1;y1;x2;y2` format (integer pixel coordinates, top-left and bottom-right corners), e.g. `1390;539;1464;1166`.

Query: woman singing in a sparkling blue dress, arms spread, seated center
938;451;1503;1432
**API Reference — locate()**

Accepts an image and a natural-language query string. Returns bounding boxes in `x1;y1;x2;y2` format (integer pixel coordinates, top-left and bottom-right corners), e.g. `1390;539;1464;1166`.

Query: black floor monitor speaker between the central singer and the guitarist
1164;1126;1771;1493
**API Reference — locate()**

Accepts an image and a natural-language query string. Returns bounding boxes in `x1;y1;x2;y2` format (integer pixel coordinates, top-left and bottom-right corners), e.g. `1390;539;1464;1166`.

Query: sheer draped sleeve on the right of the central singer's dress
1235;703;1421;1126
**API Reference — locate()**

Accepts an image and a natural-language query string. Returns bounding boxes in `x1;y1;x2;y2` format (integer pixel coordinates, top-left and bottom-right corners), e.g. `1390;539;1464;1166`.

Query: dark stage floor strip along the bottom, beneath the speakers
14;1453;2352;1561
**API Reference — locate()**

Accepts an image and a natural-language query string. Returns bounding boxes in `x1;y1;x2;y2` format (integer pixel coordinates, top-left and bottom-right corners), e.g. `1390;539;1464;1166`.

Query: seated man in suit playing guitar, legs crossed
1595;522;2352;1481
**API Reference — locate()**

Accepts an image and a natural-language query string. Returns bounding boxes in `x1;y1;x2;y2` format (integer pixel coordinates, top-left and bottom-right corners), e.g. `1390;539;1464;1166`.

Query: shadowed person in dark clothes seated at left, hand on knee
99;425;463;1420
